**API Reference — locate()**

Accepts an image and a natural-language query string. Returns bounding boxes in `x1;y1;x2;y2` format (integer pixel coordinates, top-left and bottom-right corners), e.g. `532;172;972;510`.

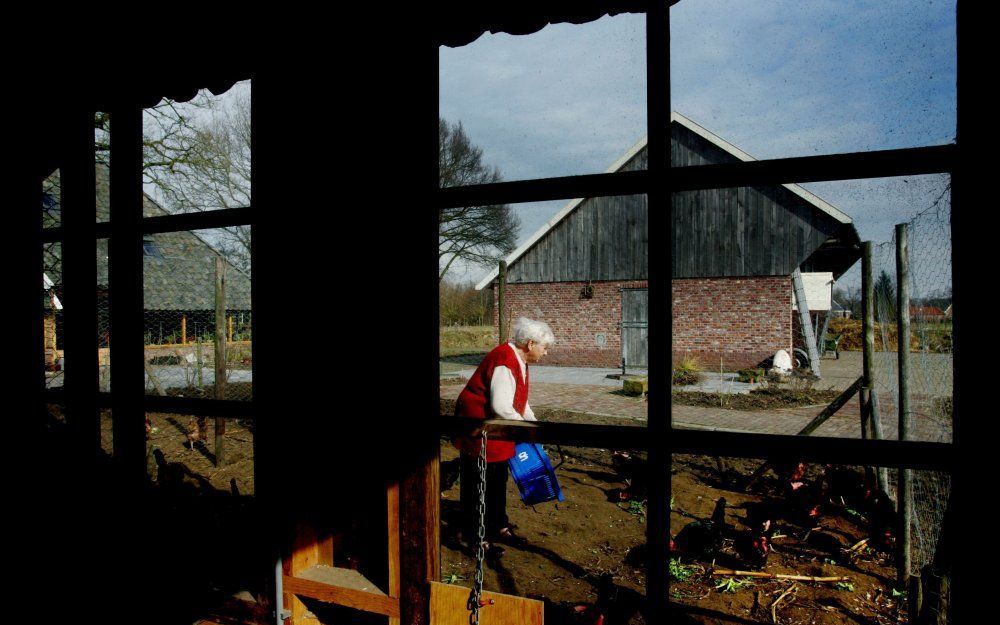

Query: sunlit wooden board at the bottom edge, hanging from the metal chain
431;582;545;625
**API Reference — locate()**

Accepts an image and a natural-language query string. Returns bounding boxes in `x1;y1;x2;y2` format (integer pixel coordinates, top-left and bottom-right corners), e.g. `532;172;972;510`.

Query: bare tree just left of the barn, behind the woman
438;119;521;280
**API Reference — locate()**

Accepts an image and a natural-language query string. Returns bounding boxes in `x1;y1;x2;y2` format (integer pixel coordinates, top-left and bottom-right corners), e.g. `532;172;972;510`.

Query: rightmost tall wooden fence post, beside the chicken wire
896;224;913;589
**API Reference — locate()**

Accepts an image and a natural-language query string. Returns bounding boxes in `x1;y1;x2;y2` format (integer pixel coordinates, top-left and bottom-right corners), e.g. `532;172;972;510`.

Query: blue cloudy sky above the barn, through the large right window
439;0;956;290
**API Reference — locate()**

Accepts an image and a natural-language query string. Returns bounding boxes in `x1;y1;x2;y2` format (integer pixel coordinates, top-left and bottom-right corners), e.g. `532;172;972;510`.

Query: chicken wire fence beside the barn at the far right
871;185;954;574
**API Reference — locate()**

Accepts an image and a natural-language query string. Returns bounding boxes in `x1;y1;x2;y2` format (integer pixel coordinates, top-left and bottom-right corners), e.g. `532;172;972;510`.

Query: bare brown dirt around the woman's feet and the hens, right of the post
441;443;906;625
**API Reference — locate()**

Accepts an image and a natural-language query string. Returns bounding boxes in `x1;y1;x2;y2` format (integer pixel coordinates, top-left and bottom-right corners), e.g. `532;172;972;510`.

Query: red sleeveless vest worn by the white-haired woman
454;343;528;462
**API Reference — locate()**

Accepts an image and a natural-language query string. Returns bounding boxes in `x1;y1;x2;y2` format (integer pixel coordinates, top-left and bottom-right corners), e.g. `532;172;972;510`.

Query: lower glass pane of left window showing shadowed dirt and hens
146;412;254;496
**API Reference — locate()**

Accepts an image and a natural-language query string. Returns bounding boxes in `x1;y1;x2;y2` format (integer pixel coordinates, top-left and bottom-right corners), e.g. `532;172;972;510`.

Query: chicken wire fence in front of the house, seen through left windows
43;231;253;400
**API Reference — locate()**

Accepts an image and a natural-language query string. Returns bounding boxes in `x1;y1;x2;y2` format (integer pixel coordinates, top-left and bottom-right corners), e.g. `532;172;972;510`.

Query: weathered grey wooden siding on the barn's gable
508;123;841;283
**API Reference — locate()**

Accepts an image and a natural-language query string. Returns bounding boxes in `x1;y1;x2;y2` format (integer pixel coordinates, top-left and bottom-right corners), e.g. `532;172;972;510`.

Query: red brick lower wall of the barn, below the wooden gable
493;277;792;371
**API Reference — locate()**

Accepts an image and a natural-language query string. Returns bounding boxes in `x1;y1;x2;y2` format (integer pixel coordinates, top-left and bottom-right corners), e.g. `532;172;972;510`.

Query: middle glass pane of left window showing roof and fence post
143;226;253;400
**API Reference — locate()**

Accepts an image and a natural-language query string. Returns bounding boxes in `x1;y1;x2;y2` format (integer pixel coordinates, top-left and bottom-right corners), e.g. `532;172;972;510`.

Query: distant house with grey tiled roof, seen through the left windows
42;165;251;355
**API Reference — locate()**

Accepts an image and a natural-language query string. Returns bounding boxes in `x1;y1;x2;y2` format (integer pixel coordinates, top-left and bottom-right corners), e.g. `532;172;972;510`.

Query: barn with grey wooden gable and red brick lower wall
477;113;860;370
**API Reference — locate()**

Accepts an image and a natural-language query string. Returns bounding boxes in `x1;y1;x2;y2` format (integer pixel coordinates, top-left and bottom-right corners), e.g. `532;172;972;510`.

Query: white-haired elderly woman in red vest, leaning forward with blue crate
455;317;555;556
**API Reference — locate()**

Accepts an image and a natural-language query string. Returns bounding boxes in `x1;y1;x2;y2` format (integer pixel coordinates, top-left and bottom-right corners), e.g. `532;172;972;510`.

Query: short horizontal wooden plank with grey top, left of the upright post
282;565;399;618
